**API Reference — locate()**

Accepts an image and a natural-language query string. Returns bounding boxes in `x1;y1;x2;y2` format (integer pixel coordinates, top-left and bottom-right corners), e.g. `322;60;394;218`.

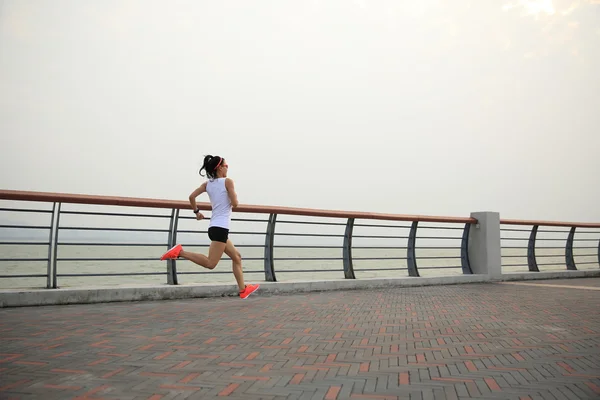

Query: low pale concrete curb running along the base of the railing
0;270;600;308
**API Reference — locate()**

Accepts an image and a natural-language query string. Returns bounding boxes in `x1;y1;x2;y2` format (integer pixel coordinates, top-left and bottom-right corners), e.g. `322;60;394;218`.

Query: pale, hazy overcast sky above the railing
0;0;600;222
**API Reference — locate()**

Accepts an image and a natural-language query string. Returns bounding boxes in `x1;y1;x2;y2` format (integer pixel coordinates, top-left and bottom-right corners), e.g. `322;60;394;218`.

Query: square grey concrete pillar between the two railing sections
469;212;502;278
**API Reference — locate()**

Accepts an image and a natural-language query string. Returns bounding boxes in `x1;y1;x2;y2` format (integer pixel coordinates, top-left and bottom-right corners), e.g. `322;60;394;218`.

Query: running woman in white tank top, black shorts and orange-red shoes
161;155;259;299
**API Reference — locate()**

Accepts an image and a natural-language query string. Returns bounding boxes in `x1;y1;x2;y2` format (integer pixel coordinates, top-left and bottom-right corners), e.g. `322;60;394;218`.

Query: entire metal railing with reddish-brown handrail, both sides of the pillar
0;190;600;288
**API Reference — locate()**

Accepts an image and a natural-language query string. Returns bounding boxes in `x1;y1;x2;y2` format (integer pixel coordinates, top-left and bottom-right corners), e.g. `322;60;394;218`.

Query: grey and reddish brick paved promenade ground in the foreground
0;279;600;400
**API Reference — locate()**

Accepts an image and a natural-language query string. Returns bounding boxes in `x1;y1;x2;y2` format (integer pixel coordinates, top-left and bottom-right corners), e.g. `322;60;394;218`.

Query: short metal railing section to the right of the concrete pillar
500;219;600;272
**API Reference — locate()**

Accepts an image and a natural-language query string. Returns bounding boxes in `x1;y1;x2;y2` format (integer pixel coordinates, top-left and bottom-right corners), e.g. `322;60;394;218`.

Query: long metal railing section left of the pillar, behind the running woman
0;190;477;288
